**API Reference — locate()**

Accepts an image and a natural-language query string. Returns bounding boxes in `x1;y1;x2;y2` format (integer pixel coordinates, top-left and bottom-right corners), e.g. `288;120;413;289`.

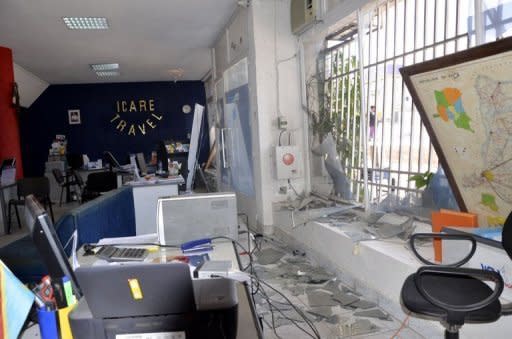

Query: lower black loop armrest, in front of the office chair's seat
414;266;504;312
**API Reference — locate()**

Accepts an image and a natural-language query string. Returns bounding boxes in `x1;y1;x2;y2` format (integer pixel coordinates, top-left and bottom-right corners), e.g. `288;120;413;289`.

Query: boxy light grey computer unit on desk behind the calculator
157;192;238;245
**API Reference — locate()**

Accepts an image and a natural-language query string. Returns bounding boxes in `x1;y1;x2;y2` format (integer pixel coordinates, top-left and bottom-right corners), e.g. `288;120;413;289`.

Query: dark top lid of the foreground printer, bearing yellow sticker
75;263;196;319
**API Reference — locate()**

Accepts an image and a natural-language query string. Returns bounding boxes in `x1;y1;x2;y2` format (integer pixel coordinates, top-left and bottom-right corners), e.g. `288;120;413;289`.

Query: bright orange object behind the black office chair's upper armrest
432;209;478;262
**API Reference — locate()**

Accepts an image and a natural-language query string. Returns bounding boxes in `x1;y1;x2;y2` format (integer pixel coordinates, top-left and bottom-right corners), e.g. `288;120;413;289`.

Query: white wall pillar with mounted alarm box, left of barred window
251;0;307;231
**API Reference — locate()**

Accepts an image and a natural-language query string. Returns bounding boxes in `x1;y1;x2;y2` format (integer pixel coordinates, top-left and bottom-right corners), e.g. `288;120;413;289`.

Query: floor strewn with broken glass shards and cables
242;238;423;339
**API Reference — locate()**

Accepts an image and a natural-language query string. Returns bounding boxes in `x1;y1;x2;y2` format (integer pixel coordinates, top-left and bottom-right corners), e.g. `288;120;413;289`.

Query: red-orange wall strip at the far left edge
0;46;23;178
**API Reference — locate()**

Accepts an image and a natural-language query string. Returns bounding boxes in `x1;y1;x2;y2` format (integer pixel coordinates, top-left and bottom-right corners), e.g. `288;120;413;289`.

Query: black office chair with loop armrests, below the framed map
401;219;512;338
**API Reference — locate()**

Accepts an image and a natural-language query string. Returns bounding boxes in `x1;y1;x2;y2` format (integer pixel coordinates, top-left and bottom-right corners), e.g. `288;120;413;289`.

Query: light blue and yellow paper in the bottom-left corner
0;260;34;339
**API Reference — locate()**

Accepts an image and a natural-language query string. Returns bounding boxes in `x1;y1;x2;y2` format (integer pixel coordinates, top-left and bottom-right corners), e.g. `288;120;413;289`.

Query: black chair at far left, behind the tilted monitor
7;177;55;233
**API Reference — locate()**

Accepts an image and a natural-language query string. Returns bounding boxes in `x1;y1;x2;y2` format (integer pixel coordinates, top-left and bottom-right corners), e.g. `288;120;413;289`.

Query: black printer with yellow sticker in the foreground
69;263;238;339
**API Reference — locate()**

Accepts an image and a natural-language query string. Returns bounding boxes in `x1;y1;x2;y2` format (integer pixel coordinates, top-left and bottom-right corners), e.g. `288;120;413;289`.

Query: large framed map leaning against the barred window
400;38;512;226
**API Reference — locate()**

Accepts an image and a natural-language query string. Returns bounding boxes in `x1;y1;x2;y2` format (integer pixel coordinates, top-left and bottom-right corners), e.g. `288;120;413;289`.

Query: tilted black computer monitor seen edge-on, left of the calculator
25;194;82;298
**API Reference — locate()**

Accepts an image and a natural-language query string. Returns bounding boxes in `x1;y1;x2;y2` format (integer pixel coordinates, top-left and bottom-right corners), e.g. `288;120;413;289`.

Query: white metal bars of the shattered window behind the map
324;0;474;202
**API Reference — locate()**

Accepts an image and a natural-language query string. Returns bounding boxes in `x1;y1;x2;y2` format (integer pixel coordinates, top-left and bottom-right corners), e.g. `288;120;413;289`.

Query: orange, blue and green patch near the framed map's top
434;88;475;132
